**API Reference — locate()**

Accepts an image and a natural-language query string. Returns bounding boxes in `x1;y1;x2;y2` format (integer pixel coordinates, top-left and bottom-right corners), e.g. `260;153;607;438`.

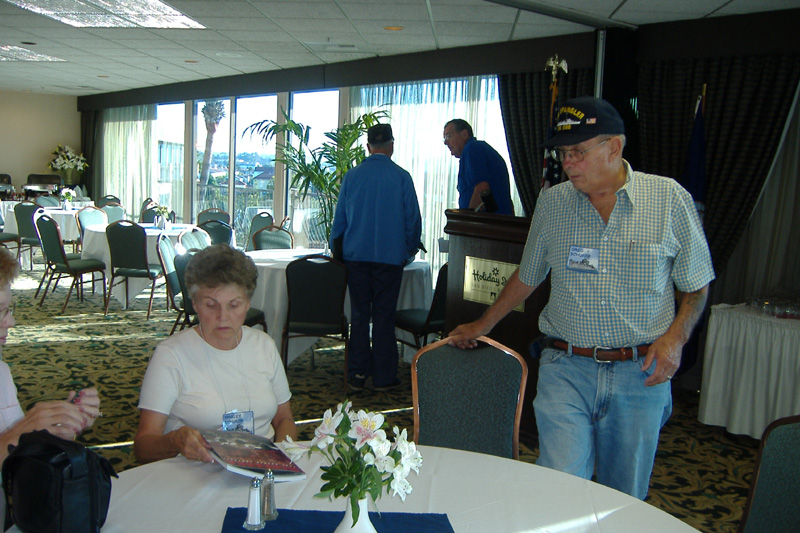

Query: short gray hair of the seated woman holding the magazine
185;244;258;300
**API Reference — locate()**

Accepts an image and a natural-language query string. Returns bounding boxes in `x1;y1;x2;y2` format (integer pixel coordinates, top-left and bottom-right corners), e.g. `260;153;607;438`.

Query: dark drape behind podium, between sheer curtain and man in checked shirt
497;68;594;216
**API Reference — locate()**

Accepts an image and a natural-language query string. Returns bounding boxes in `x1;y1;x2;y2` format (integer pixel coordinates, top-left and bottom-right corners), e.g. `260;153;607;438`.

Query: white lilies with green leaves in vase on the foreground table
286;401;422;524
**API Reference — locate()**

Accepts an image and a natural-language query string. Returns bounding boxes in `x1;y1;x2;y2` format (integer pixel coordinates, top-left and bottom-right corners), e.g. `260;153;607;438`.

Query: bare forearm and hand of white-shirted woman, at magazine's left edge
133;409;213;464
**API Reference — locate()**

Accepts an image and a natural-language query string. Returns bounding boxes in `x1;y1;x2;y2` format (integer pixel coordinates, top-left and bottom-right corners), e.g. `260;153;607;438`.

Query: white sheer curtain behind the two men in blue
350;76;522;282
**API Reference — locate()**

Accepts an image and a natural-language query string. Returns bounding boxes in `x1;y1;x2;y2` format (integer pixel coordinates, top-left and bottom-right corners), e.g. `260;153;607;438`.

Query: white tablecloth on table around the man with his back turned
247;248;433;363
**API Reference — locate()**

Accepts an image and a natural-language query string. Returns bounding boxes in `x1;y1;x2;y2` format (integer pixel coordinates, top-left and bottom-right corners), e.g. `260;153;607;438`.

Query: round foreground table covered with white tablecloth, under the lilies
94;446;695;533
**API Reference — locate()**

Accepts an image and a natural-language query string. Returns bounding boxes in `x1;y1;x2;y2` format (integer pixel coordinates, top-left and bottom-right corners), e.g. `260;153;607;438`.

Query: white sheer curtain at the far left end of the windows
100;105;160;220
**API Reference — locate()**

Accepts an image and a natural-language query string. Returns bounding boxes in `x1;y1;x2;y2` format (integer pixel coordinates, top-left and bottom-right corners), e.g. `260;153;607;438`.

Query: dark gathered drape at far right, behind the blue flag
637;53;800;272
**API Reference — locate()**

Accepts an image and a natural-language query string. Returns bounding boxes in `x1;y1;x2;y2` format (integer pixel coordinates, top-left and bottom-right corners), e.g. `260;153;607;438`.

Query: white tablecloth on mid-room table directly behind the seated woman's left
81;224;194;305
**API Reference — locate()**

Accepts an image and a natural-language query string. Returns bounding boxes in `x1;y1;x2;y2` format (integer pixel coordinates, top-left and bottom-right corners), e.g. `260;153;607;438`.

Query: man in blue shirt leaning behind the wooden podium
443;118;514;215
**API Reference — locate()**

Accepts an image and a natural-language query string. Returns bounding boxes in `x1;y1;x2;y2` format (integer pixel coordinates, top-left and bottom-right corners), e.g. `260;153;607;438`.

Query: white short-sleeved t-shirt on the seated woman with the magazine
139;327;292;438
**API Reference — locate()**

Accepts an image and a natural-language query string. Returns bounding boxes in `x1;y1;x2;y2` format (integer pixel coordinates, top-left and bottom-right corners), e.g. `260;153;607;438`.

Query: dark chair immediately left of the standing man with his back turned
281;255;350;386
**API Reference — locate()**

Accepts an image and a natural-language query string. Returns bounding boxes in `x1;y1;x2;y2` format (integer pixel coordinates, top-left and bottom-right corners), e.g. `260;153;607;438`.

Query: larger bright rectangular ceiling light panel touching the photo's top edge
7;0;205;29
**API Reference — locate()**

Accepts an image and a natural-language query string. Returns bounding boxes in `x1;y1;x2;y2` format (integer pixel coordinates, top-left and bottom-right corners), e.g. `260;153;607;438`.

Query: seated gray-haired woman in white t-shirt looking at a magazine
133;244;297;463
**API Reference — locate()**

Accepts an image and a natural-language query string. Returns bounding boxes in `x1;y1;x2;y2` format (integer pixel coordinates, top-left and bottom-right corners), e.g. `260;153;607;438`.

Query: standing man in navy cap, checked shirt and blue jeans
451;97;714;499
